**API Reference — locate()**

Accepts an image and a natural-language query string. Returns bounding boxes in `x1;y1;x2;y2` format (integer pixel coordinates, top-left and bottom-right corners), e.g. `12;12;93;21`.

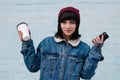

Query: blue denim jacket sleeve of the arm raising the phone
81;46;104;79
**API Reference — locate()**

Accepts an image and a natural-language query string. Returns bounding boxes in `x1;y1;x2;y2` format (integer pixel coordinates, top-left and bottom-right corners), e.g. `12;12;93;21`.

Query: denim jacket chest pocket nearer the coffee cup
41;53;59;73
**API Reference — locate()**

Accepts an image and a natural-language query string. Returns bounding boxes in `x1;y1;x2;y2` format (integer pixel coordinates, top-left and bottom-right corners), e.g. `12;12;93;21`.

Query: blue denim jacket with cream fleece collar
21;37;102;80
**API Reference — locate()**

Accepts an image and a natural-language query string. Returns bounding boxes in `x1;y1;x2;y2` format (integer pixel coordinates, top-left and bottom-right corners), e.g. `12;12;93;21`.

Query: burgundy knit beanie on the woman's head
58;6;80;21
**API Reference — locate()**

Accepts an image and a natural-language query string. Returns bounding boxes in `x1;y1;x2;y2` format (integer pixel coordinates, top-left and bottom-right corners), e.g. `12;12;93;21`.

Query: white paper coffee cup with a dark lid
17;22;30;41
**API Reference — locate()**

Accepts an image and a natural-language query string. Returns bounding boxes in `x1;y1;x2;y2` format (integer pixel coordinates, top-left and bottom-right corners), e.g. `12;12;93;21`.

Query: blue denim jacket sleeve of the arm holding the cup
21;39;40;72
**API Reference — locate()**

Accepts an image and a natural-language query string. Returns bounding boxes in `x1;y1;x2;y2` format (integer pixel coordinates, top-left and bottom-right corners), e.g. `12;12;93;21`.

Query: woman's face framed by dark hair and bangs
60;20;76;40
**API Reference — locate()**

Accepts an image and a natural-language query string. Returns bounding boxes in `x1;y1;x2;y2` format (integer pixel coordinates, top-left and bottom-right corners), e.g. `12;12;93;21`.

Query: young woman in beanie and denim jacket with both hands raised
18;7;104;80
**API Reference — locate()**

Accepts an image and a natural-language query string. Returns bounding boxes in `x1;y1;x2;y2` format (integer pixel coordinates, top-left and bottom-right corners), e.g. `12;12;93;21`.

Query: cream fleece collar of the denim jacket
54;37;80;47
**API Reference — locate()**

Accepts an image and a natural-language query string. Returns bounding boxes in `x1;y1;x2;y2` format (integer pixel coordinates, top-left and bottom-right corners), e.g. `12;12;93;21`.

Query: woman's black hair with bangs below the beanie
55;11;81;40
